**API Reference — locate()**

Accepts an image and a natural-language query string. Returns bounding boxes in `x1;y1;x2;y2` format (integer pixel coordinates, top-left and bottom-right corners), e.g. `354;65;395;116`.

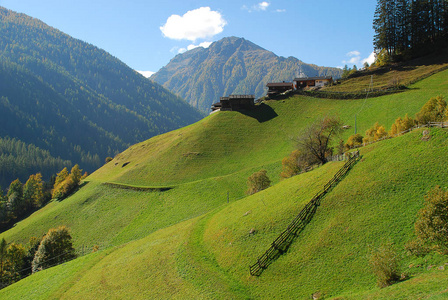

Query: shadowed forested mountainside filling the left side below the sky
0;7;202;185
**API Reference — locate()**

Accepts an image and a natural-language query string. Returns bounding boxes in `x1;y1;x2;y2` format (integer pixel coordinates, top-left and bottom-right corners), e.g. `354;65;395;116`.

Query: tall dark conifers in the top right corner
373;0;448;61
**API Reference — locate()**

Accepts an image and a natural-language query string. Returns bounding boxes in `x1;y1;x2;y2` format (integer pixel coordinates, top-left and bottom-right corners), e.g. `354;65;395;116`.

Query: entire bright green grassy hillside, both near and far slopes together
0;71;448;299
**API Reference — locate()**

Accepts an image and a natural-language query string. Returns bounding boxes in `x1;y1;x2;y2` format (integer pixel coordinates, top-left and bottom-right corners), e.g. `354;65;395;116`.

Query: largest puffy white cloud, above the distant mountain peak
160;7;227;42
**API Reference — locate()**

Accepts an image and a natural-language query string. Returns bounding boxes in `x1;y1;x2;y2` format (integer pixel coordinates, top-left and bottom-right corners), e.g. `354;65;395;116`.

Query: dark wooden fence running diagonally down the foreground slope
250;151;359;276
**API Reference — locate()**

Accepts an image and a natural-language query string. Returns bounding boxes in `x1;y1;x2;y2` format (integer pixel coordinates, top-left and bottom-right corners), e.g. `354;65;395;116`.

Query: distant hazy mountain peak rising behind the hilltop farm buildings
150;37;342;112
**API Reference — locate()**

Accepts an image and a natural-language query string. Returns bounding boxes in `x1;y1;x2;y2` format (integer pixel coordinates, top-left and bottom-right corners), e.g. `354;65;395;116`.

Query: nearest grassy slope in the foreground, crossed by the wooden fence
0;129;448;299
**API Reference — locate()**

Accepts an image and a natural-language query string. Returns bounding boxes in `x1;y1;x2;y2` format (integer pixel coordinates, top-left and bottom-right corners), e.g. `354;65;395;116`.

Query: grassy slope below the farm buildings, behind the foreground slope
4;71;448;247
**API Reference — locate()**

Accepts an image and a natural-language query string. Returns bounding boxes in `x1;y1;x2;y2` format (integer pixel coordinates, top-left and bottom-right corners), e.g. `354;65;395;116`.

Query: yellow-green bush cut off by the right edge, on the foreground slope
415;186;448;253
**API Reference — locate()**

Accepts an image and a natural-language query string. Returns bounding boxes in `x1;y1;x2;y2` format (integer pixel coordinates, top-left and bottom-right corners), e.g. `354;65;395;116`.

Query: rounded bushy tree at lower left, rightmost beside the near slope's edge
32;226;76;273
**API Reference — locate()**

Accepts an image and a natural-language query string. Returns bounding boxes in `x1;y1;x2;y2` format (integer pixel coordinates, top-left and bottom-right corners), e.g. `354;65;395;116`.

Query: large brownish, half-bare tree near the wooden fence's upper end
297;117;342;163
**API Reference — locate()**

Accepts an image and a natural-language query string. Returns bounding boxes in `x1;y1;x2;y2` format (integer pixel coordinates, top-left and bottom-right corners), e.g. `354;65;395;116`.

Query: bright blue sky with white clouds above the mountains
0;0;376;76
